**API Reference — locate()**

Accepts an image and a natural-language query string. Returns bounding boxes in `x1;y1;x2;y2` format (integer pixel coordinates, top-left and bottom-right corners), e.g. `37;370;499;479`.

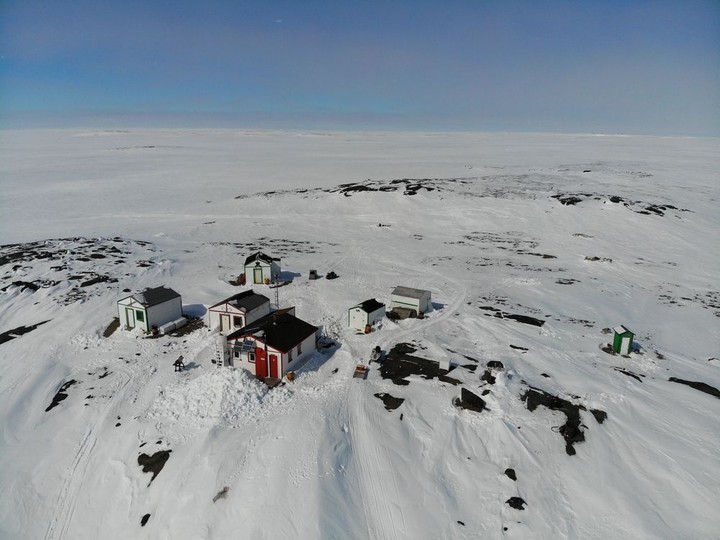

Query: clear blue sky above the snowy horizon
0;0;720;136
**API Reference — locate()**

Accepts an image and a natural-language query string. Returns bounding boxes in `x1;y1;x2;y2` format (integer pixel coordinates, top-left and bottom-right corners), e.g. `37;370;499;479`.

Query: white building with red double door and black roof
227;308;318;379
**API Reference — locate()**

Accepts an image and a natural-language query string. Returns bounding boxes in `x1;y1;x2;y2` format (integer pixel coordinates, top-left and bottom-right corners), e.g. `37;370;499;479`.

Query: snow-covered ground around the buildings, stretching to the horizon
0;130;720;539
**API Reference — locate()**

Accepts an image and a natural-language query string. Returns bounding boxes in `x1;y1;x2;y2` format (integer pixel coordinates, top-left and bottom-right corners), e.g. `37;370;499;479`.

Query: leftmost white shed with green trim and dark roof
118;287;183;332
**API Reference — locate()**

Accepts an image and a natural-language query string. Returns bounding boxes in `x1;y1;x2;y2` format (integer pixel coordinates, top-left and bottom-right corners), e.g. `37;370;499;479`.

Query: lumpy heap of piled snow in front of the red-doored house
147;368;291;429
